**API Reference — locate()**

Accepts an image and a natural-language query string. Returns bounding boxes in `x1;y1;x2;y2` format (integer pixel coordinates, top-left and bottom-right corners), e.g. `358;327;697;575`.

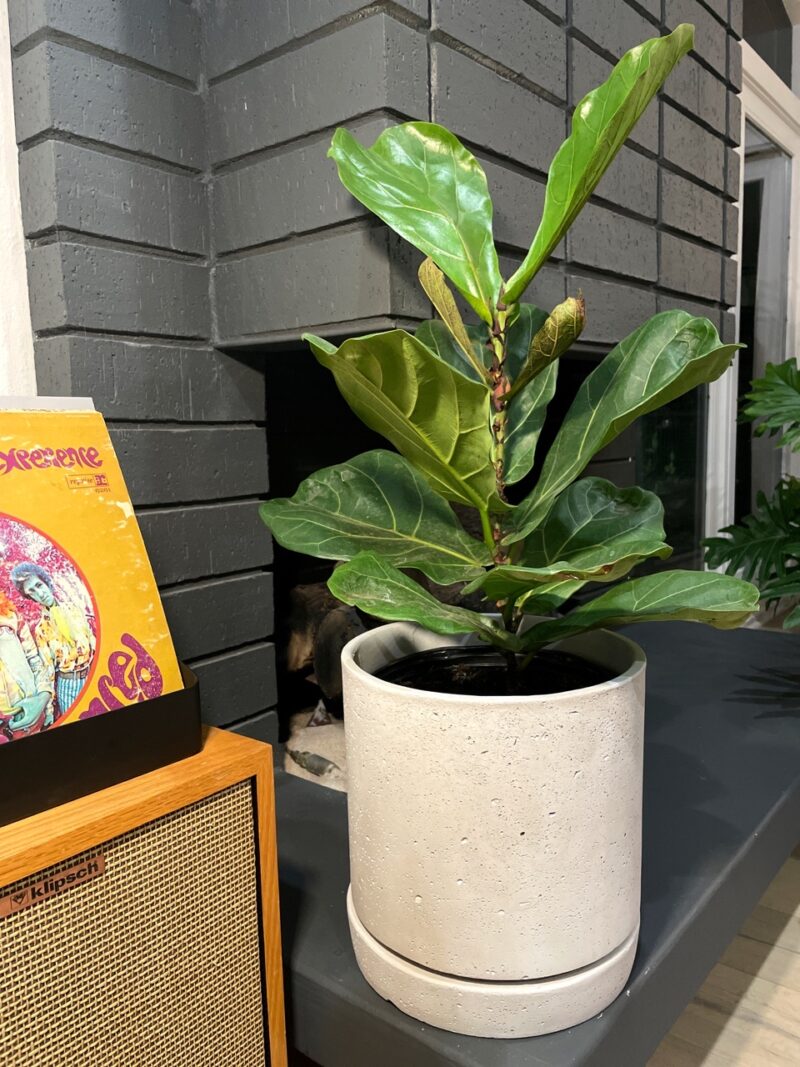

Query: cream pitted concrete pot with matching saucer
342;623;645;1037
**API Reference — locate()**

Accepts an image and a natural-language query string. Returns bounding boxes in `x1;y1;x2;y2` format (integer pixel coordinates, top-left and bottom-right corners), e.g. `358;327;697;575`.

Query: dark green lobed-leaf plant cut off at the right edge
705;360;800;630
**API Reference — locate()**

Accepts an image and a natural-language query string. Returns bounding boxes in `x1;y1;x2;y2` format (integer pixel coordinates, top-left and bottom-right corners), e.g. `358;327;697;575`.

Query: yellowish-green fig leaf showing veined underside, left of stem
304;330;505;514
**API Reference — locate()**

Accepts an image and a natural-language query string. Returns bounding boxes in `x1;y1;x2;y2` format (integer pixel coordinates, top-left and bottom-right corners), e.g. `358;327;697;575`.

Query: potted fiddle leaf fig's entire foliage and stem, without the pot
261;26;758;658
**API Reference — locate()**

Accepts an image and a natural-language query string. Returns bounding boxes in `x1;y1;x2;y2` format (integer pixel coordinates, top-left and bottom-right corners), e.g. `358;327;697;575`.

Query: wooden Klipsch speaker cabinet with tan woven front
0;730;286;1067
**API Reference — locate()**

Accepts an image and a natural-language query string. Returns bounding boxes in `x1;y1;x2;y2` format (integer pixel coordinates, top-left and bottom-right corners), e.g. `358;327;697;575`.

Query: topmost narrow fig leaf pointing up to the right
503;25;694;303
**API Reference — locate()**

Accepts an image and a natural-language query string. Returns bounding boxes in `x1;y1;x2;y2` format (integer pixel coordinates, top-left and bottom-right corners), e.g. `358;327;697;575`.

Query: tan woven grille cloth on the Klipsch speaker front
0;782;269;1067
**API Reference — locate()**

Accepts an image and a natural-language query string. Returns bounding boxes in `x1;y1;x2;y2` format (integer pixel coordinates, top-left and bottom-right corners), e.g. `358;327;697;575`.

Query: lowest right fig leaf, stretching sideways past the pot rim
519;571;758;651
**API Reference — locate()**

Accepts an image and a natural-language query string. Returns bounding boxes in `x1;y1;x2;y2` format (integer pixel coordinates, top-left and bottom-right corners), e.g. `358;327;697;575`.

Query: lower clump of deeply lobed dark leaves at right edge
703;478;800;595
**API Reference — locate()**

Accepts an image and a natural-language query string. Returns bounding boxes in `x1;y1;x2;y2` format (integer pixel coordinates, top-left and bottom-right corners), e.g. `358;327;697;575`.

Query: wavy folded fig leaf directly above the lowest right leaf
466;478;672;601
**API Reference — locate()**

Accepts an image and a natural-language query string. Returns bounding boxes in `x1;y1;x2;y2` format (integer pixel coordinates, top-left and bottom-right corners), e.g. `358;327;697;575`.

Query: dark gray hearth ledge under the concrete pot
277;623;800;1067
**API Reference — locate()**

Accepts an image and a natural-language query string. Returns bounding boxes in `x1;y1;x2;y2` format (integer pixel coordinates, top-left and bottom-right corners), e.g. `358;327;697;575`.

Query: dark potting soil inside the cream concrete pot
374;646;615;697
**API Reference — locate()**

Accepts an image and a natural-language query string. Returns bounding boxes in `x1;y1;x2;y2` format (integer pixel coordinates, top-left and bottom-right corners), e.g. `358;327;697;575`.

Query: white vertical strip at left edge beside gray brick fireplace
0;0;36;396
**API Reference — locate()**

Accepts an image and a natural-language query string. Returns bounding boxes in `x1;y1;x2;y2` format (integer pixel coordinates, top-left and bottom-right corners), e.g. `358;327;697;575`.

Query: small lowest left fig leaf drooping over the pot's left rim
327;552;516;648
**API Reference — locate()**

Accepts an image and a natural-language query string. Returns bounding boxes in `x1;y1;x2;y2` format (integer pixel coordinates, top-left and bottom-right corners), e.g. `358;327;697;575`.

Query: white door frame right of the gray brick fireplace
705;41;800;537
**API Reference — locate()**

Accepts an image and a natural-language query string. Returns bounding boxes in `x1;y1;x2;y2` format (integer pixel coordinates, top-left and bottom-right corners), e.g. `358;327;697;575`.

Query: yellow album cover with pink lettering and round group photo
0;411;182;744
